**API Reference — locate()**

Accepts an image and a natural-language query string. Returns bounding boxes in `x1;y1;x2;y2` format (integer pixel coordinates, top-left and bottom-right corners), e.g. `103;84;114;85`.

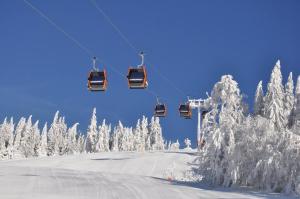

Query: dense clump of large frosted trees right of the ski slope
196;61;300;193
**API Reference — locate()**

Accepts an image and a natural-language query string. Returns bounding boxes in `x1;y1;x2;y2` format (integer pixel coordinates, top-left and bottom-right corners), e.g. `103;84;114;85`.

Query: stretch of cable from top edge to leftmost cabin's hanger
23;0;94;57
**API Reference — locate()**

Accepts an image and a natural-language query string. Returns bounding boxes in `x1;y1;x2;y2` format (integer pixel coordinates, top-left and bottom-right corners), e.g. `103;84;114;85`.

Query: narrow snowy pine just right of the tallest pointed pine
284;72;295;127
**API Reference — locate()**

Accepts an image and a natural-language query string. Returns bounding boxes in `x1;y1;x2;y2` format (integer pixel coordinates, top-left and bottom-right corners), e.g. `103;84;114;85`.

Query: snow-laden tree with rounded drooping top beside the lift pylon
200;75;244;186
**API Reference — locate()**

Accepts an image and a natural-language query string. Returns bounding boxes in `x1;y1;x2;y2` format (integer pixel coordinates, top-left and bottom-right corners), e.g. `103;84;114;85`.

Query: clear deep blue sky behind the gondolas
0;0;300;146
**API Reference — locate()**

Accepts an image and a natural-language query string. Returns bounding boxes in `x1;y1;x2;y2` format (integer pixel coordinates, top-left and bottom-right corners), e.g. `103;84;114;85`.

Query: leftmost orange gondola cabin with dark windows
88;70;107;91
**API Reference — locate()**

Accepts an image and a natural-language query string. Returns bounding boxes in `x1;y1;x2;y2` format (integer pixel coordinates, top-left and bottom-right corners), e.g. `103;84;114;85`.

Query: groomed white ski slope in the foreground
0;152;296;199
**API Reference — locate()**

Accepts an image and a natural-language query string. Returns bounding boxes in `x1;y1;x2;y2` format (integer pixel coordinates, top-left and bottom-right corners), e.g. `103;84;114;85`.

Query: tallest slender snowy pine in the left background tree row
86;108;98;153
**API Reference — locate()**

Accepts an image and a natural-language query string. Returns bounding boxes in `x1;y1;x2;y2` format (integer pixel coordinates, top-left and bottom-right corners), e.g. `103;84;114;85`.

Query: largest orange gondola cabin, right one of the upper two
127;66;148;89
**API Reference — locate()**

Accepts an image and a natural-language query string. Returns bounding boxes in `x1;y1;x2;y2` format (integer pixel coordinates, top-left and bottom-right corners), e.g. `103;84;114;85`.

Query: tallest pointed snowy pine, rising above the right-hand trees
264;60;286;130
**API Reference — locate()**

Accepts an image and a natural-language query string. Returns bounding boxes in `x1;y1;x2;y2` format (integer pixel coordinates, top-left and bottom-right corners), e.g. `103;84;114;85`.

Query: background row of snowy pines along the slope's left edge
0;108;164;160
